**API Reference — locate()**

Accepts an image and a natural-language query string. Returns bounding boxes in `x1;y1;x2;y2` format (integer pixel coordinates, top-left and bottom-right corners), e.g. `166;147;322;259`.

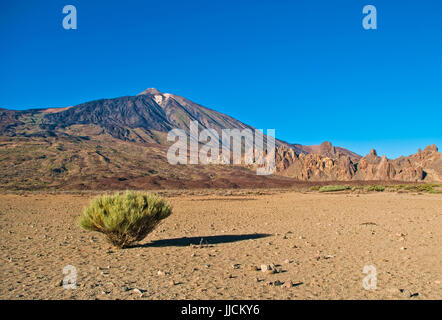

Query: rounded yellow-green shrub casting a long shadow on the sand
78;191;172;248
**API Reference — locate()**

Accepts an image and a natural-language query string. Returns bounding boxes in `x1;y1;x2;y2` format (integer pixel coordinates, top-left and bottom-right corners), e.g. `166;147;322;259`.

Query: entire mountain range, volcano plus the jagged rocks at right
0;88;442;189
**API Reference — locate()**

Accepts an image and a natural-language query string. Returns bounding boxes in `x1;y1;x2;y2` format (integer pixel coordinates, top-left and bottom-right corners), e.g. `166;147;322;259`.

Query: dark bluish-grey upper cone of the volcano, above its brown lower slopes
40;89;254;143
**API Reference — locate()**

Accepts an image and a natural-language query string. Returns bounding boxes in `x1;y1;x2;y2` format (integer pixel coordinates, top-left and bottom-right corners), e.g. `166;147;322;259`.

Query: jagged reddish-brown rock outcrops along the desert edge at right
276;142;442;182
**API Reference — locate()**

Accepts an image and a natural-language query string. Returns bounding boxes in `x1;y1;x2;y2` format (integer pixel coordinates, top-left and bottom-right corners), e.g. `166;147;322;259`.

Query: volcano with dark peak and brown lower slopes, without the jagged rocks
0;89;293;189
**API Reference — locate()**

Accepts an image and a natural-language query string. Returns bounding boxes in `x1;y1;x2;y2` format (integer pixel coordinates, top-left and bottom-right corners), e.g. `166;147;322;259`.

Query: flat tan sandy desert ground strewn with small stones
0;190;442;299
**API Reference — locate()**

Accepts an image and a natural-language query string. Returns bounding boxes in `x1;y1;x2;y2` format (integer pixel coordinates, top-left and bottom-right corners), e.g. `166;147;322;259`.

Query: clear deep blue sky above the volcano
0;0;442;158
